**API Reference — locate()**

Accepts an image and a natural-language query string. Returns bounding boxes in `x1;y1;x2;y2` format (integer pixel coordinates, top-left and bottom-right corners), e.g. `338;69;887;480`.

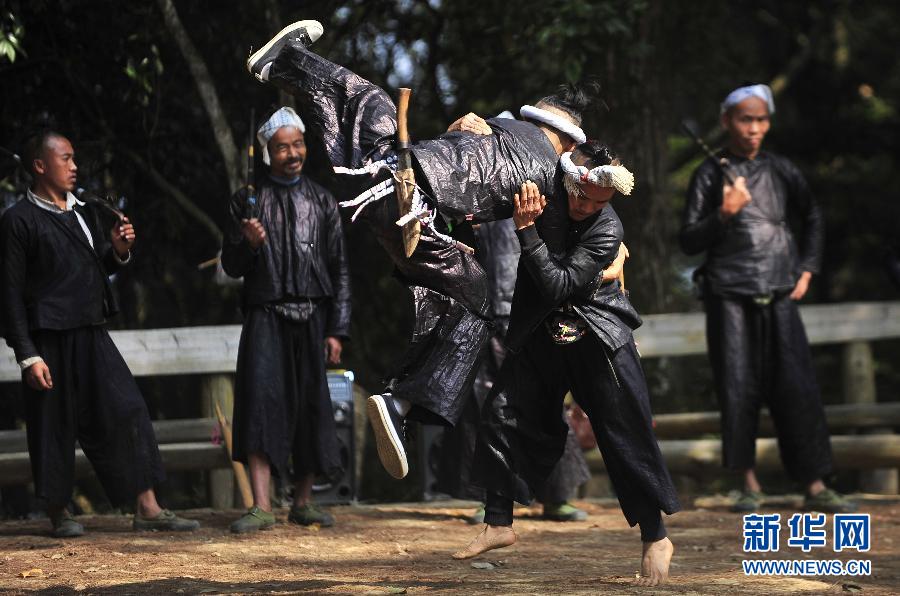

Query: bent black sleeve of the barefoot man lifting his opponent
516;220;621;304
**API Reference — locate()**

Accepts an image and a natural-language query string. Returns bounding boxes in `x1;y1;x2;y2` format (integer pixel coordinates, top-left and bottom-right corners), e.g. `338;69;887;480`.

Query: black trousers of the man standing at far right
705;295;832;484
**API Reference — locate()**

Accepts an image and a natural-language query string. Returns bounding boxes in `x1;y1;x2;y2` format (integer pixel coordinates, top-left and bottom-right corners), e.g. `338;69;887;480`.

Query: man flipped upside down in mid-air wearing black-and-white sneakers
247;21;587;478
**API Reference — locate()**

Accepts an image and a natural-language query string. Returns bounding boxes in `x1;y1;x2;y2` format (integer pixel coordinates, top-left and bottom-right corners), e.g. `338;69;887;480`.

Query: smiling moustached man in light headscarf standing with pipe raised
222;107;350;533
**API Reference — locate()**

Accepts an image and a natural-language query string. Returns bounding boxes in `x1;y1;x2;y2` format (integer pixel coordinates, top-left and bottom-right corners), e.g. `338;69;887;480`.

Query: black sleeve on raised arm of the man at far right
678;162;727;255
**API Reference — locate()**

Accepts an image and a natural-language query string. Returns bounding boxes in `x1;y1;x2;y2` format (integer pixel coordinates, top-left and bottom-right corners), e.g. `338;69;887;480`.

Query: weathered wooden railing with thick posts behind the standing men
0;302;900;496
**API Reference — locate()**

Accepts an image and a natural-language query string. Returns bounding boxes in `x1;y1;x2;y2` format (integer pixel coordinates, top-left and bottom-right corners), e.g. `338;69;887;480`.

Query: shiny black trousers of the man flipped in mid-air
269;43;490;425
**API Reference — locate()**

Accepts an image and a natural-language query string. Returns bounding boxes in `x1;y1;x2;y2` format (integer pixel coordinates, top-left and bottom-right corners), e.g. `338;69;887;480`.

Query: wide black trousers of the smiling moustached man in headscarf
232;307;342;480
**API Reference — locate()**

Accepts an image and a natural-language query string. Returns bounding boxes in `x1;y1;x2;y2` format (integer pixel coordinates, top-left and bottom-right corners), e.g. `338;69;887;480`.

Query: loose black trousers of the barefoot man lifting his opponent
474;327;680;526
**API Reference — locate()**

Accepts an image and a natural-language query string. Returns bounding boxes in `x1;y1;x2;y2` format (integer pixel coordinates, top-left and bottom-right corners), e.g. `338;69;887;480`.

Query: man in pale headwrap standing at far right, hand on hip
680;85;855;512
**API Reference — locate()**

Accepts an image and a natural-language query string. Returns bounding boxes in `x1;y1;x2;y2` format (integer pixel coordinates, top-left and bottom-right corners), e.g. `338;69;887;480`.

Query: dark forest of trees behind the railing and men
0;0;900;502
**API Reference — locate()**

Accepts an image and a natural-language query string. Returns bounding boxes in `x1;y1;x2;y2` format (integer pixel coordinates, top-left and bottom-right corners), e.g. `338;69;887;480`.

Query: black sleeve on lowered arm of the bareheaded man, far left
0;213;40;362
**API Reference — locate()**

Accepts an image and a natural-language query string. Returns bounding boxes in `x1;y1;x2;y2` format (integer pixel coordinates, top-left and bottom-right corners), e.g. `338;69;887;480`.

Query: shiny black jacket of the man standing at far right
679;152;824;296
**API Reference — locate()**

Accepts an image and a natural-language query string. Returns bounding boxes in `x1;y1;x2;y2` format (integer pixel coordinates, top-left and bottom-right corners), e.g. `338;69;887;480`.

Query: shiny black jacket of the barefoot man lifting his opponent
506;206;641;351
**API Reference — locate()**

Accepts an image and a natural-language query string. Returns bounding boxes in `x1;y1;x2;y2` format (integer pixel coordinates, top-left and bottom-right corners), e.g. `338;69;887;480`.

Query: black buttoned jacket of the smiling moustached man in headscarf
222;176;350;337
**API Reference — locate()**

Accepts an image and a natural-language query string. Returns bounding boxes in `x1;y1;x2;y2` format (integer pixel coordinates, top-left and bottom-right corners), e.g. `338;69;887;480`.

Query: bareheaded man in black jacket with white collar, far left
0;131;199;537
